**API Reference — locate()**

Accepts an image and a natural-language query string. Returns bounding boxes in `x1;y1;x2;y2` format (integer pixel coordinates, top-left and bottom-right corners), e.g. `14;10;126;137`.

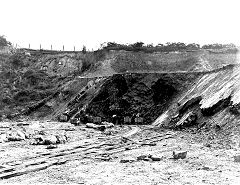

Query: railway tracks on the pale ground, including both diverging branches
0;126;174;179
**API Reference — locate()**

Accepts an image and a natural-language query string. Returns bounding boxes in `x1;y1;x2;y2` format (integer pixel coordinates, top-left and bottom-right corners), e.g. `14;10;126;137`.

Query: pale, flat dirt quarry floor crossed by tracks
0;121;240;185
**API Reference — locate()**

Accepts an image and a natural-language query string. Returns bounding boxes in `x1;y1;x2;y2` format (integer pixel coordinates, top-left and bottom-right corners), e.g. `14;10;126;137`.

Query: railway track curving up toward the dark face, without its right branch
0;127;138;179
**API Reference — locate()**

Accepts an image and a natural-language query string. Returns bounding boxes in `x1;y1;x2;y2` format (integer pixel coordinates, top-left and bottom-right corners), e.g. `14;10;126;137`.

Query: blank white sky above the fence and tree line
0;0;240;50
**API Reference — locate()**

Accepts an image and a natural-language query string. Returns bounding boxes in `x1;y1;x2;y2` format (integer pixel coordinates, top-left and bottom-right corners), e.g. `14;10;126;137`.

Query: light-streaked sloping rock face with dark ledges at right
155;66;240;130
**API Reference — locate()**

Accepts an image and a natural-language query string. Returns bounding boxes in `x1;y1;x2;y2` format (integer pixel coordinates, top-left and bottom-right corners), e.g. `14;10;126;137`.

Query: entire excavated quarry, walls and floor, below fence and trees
0;49;240;184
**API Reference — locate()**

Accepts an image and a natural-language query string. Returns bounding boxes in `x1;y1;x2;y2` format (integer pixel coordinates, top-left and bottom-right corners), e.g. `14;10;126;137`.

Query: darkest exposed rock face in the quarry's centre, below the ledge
65;74;200;124
